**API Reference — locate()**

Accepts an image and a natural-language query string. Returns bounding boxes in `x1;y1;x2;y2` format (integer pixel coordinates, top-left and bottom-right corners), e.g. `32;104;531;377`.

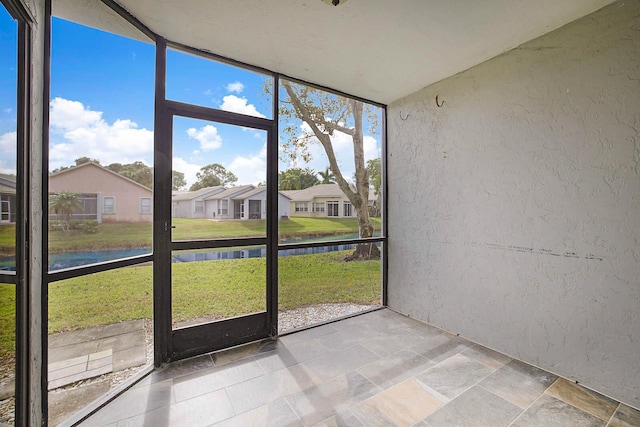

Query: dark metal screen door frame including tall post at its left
153;39;278;366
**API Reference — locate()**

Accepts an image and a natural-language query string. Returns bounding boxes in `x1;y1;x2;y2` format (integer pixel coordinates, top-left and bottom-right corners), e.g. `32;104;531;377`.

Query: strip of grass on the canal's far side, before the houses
0;217;380;256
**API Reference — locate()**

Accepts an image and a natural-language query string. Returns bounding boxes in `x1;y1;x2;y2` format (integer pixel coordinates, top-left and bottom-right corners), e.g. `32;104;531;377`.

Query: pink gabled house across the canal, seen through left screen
49;162;153;223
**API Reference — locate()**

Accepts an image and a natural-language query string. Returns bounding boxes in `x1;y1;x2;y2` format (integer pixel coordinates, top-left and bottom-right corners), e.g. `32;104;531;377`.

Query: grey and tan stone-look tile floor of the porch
82;309;640;427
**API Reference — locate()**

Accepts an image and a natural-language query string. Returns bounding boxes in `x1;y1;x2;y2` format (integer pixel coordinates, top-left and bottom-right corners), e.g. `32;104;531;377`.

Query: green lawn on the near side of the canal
0;252;380;354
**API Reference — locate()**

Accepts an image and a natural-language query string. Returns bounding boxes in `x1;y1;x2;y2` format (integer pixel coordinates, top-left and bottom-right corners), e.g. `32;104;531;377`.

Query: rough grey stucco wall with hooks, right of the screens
388;1;640;407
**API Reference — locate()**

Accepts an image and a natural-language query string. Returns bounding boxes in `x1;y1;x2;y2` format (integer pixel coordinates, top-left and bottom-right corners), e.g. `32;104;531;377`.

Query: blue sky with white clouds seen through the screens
0;7;380;186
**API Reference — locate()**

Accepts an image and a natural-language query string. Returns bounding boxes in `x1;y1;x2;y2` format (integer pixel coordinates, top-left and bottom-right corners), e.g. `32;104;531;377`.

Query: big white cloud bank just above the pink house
49;98;153;170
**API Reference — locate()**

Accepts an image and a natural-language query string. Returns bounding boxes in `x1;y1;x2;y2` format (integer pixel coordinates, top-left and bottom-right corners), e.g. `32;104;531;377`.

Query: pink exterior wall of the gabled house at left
49;165;153;222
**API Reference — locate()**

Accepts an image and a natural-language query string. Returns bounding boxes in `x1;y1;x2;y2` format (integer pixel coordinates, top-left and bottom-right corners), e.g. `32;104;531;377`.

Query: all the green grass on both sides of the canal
0;218;380;353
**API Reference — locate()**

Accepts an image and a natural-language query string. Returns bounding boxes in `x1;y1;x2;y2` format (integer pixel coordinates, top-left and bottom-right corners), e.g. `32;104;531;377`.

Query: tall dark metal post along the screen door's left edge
153;37;173;367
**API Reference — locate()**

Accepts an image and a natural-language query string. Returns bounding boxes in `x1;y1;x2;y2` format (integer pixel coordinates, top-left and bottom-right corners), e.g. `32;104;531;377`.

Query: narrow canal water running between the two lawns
0;234;372;271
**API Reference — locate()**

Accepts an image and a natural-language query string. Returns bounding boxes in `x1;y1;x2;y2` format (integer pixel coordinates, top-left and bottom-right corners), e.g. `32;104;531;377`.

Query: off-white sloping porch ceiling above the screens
53;0;613;104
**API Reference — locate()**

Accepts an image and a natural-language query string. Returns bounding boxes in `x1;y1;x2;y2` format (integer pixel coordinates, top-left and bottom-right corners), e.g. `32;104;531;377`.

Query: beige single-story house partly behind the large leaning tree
284;184;376;218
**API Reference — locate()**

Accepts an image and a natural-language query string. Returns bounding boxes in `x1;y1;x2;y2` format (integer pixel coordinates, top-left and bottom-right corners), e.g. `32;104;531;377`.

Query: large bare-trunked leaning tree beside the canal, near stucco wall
280;80;380;261
